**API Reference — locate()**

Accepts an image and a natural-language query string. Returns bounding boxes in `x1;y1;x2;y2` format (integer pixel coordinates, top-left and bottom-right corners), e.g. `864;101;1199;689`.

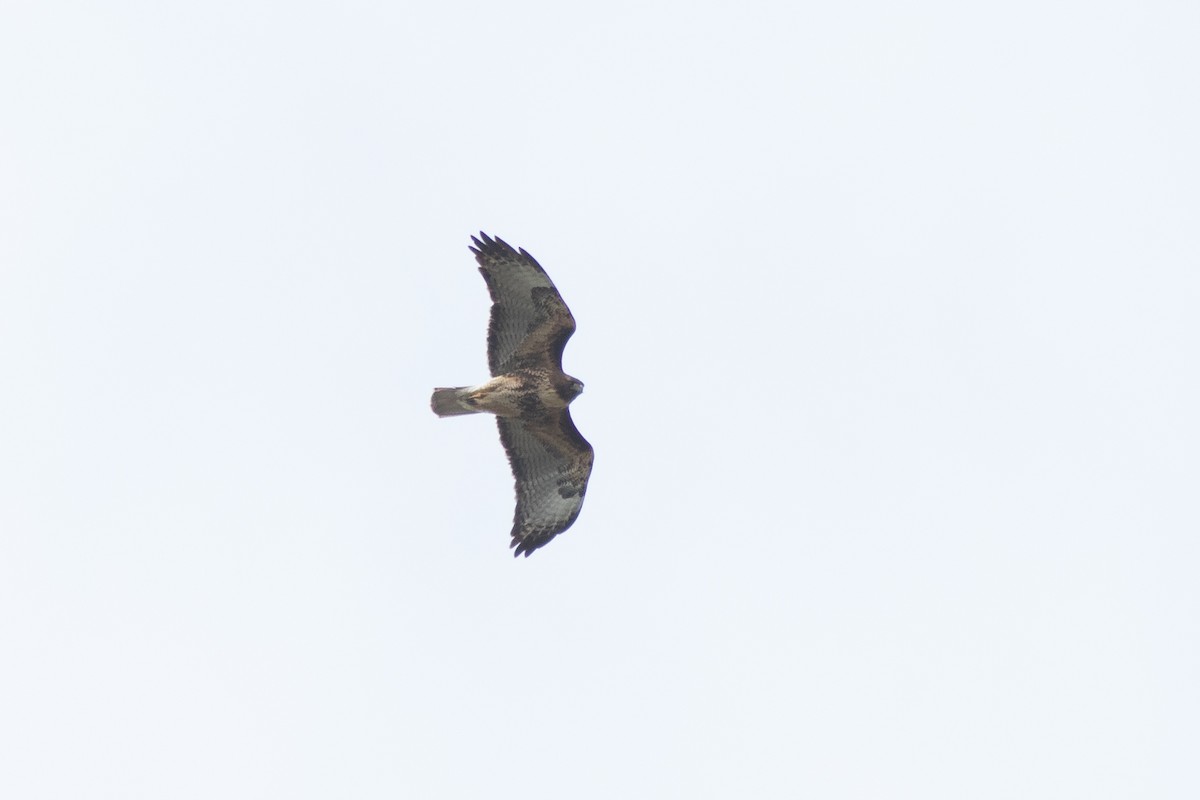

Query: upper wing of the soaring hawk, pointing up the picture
470;233;575;375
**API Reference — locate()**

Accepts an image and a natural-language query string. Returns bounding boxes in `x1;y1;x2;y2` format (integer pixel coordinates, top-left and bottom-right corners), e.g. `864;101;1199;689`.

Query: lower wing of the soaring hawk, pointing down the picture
496;409;593;557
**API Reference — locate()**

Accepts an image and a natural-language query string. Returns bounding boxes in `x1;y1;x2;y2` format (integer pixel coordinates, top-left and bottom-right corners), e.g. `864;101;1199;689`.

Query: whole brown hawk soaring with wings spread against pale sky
430;231;593;557
